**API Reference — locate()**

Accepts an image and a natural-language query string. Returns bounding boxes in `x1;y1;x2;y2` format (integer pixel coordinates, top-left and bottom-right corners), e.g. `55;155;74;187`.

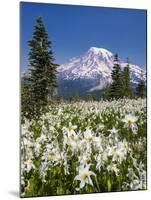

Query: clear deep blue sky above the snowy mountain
20;2;146;70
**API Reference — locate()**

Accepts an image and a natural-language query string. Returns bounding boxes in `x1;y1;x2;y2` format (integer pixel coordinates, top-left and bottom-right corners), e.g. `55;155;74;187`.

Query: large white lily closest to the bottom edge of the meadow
74;164;96;189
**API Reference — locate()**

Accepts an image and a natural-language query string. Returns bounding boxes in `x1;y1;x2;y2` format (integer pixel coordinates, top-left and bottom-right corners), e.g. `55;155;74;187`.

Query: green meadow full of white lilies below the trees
21;98;147;197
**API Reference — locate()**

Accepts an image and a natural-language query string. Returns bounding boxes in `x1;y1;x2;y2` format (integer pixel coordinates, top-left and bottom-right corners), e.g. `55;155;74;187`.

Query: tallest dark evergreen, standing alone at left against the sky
23;17;58;118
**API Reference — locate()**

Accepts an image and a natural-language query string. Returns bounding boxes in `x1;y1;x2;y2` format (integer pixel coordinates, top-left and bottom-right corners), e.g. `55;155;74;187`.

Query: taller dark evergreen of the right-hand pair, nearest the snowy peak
109;54;122;99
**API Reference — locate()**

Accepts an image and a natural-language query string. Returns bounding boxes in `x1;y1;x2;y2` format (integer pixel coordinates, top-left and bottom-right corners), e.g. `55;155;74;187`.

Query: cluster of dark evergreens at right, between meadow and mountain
102;54;146;99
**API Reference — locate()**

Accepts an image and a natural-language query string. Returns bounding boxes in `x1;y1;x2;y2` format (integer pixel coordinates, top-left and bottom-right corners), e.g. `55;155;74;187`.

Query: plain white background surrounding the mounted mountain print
0;0;151;200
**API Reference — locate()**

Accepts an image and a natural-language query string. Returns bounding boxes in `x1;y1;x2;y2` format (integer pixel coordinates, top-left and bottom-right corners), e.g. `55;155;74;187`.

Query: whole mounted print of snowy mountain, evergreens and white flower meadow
20;2;147;197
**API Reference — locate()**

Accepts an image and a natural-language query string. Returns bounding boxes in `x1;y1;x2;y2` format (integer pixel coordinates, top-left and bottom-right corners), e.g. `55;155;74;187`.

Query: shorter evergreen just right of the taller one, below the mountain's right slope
122;59;132;97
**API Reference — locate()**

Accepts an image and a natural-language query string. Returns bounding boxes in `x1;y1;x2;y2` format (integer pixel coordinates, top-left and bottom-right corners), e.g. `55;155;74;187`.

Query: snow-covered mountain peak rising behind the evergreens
58;47;146;92
